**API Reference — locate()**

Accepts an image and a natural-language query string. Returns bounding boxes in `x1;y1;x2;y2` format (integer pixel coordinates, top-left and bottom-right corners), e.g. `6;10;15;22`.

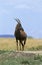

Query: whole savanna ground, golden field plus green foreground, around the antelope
0;38;42;65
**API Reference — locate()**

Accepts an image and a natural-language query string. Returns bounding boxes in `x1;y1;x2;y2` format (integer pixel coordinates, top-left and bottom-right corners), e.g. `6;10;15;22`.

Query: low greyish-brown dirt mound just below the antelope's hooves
8;52;35;57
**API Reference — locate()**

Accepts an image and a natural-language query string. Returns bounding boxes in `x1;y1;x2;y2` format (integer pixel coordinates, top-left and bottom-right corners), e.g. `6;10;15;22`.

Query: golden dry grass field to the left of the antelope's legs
0;38;16;50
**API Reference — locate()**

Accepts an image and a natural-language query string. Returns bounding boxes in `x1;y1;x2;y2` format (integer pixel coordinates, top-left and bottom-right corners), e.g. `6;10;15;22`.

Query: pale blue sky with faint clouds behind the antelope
0;0;42;38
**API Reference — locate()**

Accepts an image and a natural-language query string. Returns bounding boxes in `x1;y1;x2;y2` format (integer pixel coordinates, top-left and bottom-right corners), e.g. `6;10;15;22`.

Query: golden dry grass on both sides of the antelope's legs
0;38;42;50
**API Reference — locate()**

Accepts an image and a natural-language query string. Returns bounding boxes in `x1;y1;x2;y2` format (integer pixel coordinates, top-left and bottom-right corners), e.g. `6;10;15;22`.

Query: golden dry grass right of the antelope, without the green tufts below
25;39;42;50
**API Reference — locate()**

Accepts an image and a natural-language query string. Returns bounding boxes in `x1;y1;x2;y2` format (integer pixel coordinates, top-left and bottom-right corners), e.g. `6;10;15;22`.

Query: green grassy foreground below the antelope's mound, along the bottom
0;51;42;65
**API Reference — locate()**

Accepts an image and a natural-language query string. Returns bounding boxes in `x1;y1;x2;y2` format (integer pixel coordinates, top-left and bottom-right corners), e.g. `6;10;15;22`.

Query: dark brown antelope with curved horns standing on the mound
14;18;27;50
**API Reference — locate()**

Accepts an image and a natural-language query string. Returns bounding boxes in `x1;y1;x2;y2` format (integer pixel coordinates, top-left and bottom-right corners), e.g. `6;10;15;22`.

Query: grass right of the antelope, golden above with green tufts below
25;39;42;50
